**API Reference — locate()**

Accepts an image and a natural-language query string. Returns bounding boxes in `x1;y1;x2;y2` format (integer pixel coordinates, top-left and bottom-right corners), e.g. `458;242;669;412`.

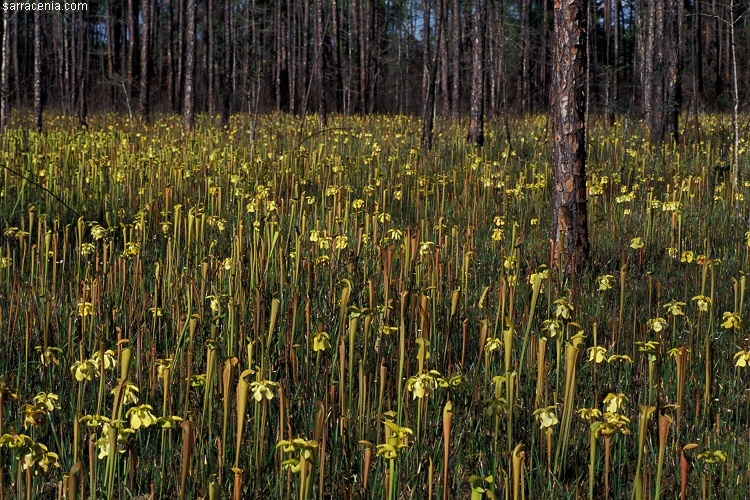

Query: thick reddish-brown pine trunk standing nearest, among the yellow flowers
551;0;589;272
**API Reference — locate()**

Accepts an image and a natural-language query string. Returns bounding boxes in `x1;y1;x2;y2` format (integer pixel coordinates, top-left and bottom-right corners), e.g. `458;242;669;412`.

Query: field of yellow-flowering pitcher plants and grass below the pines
0;111;750;500
